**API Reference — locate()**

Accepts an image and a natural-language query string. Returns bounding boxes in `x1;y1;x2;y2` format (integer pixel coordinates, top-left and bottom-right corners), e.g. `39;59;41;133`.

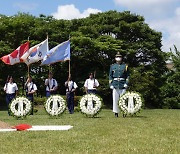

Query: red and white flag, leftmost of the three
1;42;29;65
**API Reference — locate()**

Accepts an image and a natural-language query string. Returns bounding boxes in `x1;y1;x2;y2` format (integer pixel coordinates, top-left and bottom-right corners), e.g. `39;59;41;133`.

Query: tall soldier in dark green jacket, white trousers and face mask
109;52;129;117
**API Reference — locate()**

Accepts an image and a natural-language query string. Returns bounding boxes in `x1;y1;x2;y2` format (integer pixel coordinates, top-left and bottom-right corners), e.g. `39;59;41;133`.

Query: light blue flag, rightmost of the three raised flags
41;40;70;65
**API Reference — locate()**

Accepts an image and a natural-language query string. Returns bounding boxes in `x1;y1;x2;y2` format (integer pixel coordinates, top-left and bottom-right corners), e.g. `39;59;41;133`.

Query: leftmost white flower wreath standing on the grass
9;97;32;117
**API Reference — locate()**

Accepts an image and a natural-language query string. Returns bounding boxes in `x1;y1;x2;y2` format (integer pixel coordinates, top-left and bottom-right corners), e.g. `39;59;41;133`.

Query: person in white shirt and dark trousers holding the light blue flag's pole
65;75;78;114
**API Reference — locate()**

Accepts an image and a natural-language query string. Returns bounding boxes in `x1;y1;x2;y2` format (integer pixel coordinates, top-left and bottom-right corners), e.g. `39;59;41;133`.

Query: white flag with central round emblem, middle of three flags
21;39;49;65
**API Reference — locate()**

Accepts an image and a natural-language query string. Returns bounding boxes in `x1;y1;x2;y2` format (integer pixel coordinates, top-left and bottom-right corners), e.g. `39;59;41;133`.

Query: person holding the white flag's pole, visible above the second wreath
45;72;58;97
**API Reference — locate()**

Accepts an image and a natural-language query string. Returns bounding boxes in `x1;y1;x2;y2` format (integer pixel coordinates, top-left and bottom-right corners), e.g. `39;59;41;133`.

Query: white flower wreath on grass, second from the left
45;95;66;116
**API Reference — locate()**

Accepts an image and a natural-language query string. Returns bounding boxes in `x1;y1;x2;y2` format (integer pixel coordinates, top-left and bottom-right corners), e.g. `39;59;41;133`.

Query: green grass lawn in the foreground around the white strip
0;108;180;154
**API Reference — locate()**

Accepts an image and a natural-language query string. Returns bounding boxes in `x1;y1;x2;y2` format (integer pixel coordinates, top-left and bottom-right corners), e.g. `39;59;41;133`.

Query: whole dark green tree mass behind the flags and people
0;11;169;107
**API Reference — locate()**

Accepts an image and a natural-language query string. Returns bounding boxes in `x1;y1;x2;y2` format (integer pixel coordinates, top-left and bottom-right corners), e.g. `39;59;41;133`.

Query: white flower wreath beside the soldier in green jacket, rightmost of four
119;92;142;115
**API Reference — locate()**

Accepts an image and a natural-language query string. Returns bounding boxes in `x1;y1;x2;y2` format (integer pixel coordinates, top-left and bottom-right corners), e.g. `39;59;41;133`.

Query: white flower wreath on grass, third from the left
80;94;102;116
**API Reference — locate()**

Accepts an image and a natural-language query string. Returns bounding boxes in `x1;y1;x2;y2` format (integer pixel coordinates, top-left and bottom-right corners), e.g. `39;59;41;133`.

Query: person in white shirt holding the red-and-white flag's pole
25;76;37;115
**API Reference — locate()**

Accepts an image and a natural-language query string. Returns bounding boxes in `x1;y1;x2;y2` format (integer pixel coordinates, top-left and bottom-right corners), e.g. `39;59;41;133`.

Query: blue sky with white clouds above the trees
0;0;180;52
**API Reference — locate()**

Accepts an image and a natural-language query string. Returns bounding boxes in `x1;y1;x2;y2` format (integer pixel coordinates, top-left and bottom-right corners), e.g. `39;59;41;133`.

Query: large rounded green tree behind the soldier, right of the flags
68;11;166;107
